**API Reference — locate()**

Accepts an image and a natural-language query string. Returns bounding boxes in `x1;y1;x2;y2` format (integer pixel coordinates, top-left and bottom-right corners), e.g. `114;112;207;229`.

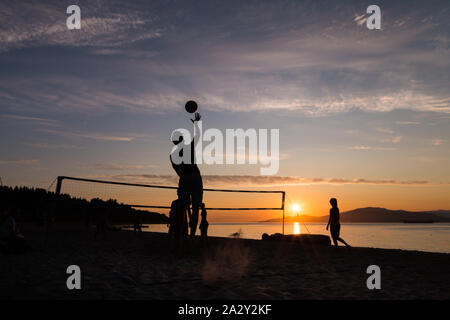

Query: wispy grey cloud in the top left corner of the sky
0;1;161;52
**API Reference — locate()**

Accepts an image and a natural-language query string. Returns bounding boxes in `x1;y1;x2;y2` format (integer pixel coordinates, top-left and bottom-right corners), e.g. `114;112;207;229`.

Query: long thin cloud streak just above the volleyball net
107;174;432;188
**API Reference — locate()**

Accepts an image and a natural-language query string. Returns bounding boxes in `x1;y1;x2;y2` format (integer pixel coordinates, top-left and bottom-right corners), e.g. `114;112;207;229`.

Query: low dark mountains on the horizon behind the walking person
262;207;450;222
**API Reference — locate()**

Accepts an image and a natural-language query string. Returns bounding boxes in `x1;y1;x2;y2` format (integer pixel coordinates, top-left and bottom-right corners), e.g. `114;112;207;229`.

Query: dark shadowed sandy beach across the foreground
0;224;450;299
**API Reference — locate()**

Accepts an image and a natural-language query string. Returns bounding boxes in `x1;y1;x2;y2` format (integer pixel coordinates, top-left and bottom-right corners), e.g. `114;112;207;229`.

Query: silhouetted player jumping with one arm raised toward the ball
170;112;203;239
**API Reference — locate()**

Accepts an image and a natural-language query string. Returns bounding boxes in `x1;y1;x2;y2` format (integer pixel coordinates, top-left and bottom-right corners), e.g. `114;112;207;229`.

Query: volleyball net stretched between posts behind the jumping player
51;176;286;229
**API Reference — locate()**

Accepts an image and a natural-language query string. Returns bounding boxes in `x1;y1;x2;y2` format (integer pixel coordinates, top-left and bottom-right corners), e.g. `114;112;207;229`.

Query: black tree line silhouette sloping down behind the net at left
0;186;168;224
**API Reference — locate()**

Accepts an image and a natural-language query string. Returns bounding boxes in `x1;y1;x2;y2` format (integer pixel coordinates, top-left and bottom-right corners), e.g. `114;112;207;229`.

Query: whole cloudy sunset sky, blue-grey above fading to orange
0;0;450;219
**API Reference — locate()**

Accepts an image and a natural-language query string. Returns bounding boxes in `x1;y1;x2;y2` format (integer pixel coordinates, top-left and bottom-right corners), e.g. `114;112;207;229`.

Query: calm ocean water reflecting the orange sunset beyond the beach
143;223;450;253
